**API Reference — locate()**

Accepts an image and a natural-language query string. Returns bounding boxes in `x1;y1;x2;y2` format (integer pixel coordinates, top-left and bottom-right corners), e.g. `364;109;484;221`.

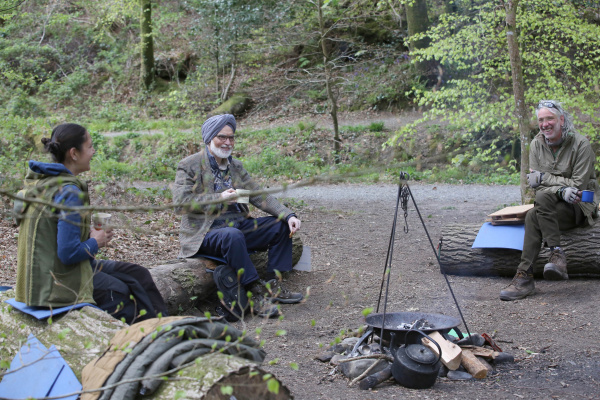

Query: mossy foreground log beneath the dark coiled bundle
0;290;293;400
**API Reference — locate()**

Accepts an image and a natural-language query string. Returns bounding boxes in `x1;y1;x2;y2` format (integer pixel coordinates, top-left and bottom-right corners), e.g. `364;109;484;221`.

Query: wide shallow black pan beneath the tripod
365;312;462;345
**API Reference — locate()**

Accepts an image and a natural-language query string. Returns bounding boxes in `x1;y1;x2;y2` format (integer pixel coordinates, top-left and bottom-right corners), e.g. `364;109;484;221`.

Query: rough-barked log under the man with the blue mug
440;224;600;278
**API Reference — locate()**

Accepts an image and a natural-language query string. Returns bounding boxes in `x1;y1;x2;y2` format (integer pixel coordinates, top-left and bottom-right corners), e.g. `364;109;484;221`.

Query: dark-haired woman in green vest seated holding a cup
16;124;167;324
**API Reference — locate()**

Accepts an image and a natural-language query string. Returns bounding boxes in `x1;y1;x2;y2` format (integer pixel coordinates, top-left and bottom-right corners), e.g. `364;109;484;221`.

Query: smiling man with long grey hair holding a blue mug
500;100;600;300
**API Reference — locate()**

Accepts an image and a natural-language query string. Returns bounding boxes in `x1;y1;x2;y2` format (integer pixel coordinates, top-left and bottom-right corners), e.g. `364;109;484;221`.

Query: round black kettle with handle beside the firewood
390;329;442;389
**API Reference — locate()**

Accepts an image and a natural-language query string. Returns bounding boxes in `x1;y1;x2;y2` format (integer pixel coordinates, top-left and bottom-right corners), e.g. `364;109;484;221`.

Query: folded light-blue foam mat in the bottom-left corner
0;334;82;400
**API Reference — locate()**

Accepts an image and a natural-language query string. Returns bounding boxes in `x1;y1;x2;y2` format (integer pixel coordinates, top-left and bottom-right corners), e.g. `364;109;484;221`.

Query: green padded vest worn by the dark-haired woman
16;170;95;307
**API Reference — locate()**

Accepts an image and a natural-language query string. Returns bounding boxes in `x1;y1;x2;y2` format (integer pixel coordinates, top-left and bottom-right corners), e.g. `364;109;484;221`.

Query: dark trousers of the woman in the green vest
92;260;168;324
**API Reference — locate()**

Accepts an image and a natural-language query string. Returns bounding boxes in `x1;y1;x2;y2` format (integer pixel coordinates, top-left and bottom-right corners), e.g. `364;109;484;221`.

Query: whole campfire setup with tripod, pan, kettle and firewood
317;172;514;389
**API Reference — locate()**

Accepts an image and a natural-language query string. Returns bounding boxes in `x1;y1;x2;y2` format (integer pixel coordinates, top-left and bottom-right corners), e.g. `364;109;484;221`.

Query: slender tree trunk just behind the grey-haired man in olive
505;0;533;204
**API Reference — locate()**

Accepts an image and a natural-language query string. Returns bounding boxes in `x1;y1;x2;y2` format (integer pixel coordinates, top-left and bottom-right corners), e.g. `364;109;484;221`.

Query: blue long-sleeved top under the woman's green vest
29;161;98;265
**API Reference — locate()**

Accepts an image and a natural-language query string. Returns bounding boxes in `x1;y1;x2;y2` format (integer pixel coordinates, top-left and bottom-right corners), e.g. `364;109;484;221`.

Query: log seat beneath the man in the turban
150;236;302;315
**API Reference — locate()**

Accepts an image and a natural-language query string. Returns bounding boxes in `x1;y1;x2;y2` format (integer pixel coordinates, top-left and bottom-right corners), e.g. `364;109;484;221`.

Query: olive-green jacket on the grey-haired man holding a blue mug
529;132;600;225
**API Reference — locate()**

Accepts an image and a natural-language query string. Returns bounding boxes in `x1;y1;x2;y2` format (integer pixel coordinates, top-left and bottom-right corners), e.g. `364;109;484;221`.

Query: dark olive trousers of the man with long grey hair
518;191;586;271
